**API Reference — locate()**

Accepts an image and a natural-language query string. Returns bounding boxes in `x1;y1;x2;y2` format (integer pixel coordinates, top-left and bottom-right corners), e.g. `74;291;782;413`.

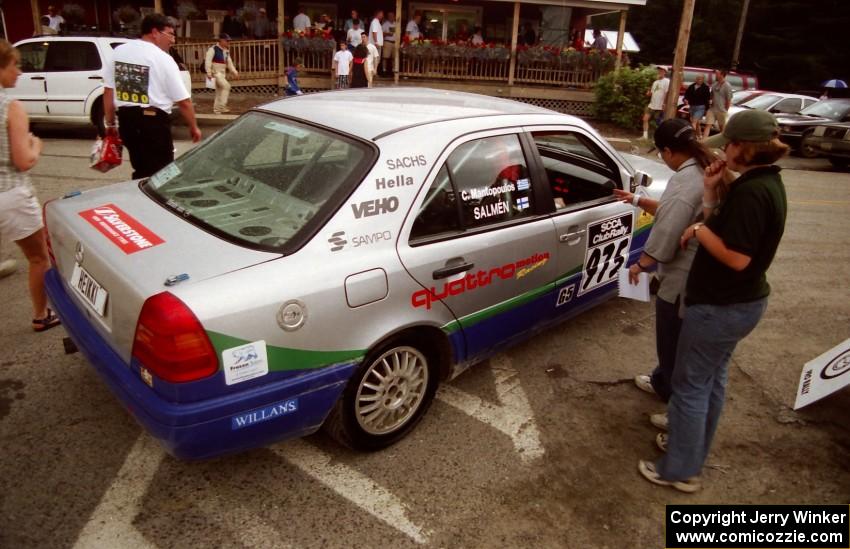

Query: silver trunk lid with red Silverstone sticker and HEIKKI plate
45;181;280;361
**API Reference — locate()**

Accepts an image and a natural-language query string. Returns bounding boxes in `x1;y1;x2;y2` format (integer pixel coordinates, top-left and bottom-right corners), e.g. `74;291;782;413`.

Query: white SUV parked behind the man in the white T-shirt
11;36;192;134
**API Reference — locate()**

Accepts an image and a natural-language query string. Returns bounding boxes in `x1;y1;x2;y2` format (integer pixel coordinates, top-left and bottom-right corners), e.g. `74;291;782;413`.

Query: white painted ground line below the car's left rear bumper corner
74;433;165;549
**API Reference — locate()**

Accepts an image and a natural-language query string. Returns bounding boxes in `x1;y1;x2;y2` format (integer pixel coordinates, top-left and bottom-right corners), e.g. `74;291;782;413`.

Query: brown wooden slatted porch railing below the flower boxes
174;40;604;89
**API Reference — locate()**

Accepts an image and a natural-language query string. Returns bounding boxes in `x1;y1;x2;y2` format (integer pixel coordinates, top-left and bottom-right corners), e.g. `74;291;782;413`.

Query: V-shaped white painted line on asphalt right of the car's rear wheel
437;354;545;463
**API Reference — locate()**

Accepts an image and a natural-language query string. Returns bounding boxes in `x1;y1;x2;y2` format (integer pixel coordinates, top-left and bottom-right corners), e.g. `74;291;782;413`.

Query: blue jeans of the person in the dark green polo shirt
655;298;767;481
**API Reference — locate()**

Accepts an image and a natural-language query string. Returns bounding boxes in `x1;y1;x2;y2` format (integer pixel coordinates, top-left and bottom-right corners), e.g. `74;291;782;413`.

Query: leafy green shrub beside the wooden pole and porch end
593;67;658;129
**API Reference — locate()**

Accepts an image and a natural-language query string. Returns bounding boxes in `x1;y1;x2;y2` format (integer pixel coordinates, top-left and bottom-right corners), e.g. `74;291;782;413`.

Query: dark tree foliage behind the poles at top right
593;0;850;92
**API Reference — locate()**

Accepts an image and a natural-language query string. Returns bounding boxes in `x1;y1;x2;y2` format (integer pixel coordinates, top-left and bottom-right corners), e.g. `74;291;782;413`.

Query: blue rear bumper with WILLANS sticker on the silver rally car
45;269;358;459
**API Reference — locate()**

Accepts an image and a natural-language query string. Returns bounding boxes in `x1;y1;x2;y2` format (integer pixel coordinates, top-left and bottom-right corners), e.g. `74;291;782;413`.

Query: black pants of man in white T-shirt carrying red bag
118;107;174;179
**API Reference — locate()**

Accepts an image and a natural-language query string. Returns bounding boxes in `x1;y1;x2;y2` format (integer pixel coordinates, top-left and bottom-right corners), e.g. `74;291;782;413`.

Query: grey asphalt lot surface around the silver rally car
0;122;850;548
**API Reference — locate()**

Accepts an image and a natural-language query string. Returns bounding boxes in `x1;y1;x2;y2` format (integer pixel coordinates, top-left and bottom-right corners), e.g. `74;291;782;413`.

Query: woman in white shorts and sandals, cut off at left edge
0;39;60;332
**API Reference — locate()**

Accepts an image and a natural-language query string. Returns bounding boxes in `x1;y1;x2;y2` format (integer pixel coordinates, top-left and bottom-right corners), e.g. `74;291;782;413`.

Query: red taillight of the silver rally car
133;292;218;383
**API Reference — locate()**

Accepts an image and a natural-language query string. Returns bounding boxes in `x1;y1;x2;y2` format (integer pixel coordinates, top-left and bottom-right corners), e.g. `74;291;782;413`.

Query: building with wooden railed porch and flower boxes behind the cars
0;0;646;114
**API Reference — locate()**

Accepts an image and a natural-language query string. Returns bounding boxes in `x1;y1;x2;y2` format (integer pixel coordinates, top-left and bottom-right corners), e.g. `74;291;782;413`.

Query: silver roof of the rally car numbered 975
257;87;558;140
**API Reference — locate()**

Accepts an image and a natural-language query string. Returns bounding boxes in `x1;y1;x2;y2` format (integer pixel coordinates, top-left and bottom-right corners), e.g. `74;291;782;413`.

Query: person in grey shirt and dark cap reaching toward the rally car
614;118;714;416
